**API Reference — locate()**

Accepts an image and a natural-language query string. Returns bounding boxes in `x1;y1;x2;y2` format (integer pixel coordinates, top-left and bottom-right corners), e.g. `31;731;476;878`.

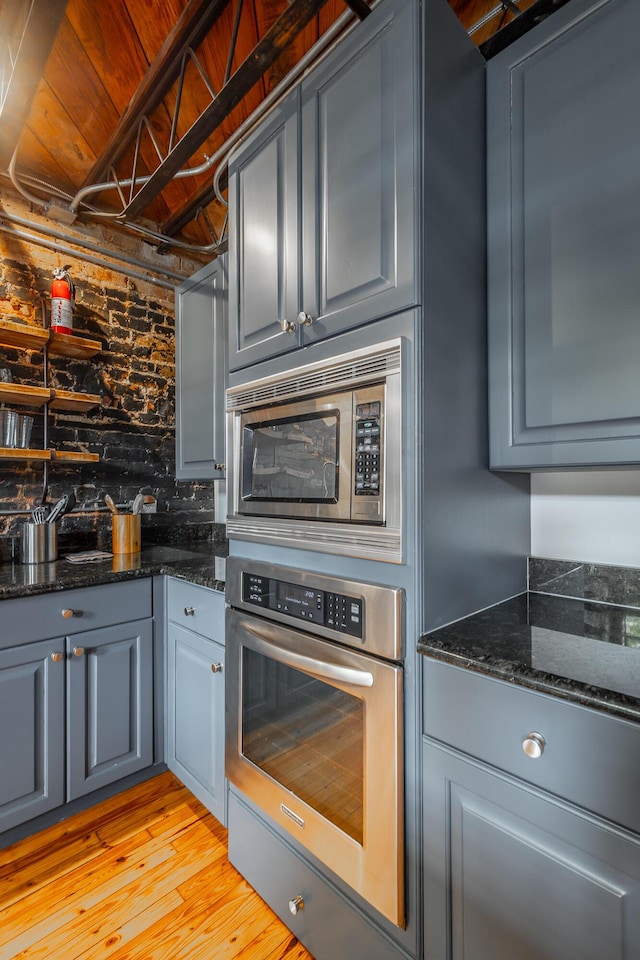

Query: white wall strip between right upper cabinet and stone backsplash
531;470;640;567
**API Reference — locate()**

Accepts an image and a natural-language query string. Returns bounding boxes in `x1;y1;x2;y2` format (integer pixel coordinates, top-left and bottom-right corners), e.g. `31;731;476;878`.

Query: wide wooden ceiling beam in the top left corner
0;0;67;170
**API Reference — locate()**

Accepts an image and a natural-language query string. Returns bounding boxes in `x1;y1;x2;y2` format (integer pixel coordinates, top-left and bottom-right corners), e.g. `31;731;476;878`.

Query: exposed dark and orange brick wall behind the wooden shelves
0;197;213;539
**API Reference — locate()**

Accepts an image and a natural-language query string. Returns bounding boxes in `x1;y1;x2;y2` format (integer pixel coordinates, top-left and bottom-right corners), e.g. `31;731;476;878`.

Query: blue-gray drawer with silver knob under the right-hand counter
423;657;640;831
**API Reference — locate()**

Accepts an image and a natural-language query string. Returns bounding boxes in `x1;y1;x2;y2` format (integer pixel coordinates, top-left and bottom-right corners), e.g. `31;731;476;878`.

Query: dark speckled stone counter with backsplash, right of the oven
418;558;640;722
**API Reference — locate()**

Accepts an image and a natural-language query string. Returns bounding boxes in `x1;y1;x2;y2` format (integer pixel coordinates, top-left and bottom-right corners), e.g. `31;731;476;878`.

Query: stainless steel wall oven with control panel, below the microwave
226;557;404;926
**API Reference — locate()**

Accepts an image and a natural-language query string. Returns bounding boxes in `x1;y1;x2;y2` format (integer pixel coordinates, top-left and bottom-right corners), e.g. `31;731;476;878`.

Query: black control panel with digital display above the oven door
242;571;364;640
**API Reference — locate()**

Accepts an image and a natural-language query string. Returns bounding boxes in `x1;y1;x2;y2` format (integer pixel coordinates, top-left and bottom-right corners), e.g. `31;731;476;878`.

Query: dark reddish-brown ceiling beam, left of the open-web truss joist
83;0;231;186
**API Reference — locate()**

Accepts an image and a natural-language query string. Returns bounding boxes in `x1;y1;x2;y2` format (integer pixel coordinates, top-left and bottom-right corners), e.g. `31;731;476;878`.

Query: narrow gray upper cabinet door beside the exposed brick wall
176;257;227;480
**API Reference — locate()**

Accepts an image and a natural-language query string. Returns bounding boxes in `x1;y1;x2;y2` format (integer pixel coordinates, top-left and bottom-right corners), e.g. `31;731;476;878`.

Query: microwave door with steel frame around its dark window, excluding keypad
239;393;353;520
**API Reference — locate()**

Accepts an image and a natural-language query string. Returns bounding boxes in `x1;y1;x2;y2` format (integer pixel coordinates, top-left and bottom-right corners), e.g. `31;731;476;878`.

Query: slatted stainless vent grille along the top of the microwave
227;341;400;410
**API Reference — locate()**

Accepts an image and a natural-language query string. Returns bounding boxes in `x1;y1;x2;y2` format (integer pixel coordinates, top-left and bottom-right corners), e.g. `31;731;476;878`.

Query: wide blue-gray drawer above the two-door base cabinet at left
0;577;152;648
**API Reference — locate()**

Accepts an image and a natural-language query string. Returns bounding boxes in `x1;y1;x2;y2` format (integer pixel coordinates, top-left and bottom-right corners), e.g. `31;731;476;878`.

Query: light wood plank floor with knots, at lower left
0;773;313;960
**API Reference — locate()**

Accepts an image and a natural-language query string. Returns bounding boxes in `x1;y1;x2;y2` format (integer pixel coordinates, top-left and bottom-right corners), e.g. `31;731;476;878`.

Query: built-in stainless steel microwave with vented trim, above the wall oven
227;340;402;559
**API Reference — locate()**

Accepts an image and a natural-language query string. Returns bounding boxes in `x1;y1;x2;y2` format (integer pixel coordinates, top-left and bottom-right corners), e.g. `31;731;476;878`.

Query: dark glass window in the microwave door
242;409;340;503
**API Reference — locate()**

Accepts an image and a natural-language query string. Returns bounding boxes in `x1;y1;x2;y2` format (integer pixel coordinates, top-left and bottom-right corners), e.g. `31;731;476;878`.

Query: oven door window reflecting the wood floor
241;647;365;844
